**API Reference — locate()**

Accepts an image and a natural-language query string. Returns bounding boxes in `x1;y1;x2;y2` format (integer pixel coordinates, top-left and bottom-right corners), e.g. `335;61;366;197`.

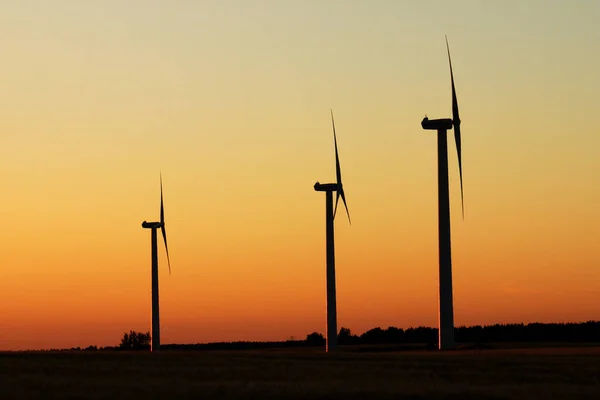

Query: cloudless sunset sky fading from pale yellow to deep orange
0;0;600;349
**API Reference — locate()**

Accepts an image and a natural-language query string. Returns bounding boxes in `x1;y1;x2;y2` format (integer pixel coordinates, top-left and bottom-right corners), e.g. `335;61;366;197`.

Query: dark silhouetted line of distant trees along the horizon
64;321;600;350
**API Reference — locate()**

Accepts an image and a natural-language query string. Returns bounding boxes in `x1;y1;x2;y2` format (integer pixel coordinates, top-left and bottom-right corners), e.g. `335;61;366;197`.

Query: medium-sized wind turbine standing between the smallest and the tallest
314;110;352;352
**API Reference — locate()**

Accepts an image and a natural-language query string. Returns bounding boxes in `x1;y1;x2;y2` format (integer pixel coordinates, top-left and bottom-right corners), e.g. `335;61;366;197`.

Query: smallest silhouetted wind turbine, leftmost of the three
142;173;171;351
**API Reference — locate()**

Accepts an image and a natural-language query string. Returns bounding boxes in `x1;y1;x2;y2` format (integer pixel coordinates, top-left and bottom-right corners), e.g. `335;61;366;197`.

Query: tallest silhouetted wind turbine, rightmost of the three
421;37;465;350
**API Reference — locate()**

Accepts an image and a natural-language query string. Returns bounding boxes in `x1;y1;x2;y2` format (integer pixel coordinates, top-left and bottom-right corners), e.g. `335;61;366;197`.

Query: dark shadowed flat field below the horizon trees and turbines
0;346;600;400
